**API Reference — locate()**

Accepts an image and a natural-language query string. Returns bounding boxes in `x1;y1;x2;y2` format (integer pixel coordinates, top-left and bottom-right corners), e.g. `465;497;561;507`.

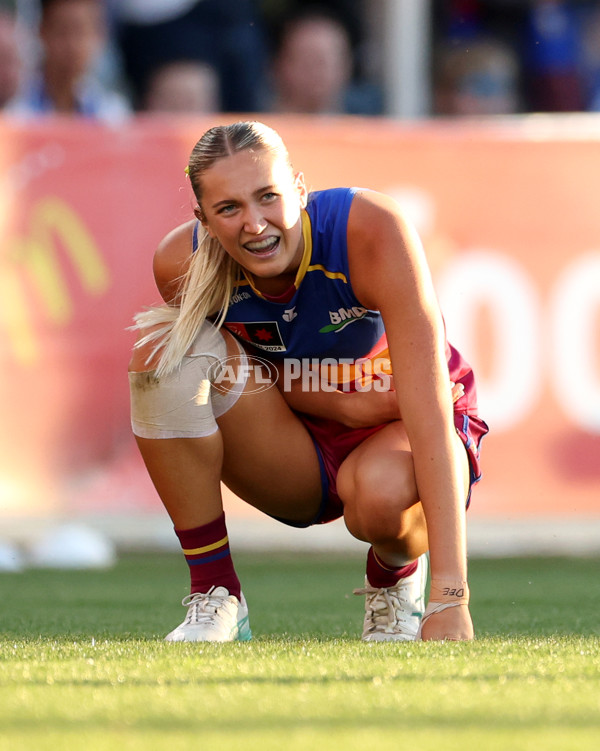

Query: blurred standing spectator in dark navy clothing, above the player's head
112;0;266;112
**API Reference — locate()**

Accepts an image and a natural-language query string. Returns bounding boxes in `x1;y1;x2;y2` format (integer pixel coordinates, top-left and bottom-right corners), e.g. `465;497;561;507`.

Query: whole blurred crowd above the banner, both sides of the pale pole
0;0;600;123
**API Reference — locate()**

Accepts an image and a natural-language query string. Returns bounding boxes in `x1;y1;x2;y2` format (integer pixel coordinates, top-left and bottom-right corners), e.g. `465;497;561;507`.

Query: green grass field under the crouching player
0;554;600;751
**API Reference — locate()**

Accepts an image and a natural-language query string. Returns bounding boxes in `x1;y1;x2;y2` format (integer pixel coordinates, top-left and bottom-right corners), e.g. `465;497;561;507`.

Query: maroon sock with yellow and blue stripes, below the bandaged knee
175;514;241;600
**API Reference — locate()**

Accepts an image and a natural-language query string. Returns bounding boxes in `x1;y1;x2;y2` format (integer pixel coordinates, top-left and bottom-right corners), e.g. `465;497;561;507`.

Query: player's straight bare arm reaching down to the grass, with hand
348;192;472;638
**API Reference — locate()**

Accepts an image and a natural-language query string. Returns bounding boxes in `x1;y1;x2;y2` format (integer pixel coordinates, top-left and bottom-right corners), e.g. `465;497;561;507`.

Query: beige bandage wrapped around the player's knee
129;322;246;438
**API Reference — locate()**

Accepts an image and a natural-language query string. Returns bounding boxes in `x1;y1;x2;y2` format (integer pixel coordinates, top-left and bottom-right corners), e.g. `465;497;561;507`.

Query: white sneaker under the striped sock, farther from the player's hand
165;587;252;641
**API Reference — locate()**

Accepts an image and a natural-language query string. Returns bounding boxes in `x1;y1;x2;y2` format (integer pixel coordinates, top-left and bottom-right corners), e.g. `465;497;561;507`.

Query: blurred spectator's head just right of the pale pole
433;38;519;116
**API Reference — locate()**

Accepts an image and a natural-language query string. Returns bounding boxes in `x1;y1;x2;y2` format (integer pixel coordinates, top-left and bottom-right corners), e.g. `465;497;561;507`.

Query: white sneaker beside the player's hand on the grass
354;554;428;641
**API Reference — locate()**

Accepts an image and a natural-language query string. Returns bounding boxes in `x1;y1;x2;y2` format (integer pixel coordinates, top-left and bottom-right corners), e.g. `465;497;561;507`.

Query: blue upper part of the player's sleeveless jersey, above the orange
225;188;385;372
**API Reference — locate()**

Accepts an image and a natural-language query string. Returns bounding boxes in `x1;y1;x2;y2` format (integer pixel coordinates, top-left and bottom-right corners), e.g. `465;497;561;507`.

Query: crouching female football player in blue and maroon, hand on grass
130;122;487;641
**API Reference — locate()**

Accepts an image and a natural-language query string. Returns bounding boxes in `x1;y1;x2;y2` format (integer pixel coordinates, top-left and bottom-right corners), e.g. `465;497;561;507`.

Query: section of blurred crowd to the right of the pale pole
432;0;600;115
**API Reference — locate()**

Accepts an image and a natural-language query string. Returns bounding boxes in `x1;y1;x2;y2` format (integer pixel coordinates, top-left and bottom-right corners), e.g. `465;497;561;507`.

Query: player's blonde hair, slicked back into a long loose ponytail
134;121;292;377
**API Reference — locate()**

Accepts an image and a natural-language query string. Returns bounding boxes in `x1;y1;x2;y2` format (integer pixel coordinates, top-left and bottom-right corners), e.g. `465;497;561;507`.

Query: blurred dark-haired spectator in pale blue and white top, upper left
8;0;130;123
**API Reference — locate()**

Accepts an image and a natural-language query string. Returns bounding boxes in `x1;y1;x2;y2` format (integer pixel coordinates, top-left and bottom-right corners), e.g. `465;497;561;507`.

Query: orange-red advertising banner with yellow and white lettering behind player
0;116;600;517
